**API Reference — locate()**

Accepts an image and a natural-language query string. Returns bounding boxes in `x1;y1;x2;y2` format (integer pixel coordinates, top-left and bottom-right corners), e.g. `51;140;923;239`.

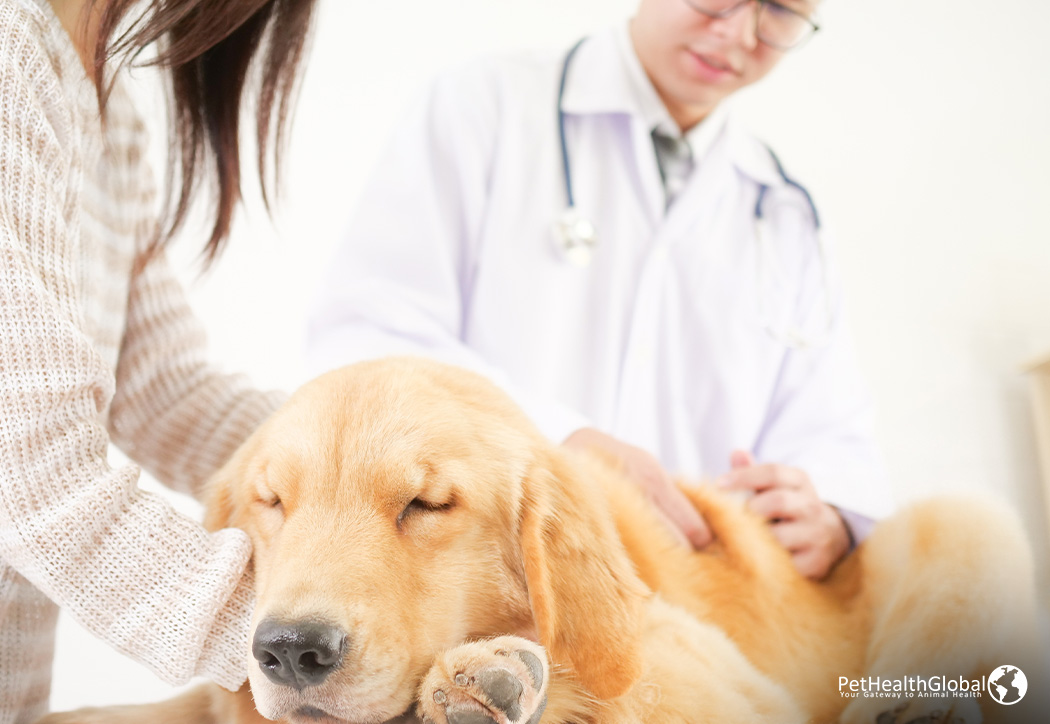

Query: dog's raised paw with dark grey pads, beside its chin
419;636;550;724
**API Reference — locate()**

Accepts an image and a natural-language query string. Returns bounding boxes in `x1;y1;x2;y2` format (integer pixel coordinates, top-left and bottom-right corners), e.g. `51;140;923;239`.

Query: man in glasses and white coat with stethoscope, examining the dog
310;0;888;578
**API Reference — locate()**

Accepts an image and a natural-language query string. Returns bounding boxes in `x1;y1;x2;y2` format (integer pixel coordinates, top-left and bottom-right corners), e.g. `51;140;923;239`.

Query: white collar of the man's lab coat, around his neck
562;21;783;187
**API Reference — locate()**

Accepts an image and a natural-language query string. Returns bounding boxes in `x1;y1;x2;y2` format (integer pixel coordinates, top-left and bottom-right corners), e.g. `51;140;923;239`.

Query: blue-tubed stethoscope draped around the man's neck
553;38;835;349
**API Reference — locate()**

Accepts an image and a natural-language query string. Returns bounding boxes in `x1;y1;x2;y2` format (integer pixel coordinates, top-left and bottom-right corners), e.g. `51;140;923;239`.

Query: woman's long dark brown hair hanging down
90;0;314;267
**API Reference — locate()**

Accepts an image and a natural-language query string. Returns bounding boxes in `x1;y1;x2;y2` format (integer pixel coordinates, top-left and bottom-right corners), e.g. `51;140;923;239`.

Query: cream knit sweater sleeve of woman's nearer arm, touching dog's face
0;5;262;688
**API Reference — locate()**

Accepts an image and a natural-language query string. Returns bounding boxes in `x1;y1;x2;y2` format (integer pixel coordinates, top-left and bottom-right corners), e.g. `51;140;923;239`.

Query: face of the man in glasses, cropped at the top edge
631;0;814;130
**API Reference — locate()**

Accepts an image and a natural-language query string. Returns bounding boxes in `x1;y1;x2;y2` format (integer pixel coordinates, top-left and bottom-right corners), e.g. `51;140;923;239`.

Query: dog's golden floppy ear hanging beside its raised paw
521;450;649;699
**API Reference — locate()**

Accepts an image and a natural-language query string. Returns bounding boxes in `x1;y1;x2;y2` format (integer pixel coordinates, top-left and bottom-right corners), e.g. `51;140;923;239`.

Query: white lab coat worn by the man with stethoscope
309;28;889;516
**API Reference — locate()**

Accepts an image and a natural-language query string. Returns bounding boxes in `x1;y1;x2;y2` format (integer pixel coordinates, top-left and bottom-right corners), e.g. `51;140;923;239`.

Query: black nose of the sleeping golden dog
252;619;347;688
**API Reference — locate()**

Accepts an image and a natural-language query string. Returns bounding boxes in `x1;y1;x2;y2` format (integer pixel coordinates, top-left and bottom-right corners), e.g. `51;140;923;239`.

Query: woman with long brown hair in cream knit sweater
0;0;313;724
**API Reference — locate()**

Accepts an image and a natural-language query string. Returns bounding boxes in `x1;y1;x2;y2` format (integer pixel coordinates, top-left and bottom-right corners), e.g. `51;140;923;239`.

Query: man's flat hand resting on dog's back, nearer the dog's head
563;427;711;549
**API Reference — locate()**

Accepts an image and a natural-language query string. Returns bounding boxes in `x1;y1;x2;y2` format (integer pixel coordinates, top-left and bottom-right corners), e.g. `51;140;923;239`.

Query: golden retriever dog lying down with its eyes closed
38;359;1045;724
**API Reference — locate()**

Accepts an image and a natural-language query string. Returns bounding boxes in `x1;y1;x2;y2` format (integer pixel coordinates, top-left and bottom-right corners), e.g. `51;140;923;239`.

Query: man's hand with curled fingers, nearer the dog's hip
719;450;849;579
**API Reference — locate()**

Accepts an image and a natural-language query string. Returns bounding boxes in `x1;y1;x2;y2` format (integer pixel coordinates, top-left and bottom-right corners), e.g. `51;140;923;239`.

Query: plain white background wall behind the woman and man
53;0;1050;708
